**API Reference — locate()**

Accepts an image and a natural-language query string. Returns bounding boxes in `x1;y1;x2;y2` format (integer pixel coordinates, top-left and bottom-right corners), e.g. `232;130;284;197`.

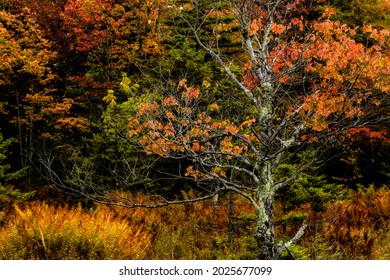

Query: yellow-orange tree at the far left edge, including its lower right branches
0;8;87;180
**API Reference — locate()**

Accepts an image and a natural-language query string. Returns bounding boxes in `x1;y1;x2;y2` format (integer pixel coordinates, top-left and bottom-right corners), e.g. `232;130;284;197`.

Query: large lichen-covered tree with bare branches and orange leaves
38;0;390;259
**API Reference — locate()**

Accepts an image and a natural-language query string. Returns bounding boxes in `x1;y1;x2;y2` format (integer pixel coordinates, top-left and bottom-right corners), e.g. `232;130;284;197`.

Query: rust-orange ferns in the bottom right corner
323;189;390;259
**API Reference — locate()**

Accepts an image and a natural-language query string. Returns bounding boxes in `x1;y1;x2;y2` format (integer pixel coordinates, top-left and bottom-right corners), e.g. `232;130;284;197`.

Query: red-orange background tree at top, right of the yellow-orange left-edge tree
61;0;167;116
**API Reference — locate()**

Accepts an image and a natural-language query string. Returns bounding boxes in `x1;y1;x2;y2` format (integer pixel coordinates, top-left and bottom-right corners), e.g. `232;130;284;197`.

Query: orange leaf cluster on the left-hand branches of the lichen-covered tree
128;80;259;171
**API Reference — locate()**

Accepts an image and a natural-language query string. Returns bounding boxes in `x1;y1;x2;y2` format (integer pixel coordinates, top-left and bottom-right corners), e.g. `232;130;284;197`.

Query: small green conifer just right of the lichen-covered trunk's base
275;153;344;259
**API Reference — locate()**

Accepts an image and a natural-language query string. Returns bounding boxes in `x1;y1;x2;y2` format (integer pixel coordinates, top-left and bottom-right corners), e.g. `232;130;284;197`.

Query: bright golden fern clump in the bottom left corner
0;203;151;259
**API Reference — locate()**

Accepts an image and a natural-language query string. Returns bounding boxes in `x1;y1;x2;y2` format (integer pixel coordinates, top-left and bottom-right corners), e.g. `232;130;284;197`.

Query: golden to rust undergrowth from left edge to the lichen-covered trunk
0;192;251;260
